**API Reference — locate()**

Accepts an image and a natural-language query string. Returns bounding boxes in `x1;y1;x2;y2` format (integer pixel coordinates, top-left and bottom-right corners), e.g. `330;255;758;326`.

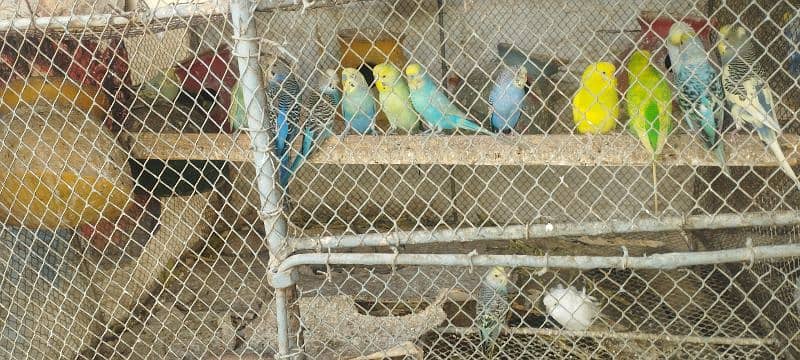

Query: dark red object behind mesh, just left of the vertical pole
175;44;239;133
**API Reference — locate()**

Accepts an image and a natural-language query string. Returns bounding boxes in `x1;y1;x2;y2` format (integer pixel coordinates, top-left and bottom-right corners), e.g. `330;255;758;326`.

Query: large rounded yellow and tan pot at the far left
0;78;133;230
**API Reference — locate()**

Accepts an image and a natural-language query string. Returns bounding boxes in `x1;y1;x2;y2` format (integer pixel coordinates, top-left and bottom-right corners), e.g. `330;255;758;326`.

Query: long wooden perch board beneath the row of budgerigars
132;133;800;166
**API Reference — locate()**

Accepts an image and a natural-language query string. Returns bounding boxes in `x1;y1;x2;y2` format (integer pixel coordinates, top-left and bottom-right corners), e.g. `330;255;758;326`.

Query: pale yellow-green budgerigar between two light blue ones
372;62;420;134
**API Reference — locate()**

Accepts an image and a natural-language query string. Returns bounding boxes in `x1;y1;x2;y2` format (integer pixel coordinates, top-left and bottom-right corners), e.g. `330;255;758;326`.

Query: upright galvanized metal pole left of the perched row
231;0;300;358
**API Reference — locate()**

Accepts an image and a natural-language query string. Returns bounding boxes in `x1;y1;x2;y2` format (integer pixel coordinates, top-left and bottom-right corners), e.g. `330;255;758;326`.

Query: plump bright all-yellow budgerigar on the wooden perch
572;62;619;134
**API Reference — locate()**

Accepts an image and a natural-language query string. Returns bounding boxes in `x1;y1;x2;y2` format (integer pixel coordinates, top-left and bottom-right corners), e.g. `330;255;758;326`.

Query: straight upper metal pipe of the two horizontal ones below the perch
290;211;800;250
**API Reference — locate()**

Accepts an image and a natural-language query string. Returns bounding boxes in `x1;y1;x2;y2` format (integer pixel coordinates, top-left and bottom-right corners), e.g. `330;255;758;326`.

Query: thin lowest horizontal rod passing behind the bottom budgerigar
434;326;779;346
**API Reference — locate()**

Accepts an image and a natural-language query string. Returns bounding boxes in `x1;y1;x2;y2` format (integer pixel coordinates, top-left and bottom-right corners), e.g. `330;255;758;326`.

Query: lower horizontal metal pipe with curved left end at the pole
278;244;800;271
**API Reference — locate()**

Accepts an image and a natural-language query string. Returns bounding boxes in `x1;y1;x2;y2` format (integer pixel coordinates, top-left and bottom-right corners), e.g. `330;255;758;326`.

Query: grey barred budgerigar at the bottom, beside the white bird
475;266;511;358
